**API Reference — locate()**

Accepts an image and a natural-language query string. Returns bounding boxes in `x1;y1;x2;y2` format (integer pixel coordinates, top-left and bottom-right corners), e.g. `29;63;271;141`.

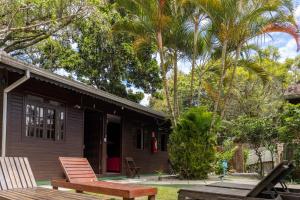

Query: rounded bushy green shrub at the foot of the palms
169;107;216;179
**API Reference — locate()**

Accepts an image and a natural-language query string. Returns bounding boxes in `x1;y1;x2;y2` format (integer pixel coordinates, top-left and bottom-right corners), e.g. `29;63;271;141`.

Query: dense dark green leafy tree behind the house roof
16;4;161;102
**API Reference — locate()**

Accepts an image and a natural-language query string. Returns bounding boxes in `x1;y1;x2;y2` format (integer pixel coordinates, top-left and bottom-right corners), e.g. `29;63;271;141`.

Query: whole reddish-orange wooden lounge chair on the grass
51;157;157;200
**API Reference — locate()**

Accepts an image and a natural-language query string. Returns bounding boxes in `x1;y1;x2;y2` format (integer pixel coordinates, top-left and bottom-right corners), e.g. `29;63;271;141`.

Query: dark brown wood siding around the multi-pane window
7;94;83;180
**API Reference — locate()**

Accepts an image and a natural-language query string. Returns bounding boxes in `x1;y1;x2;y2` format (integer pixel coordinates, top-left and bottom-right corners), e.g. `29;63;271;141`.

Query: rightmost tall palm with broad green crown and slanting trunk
196;0;293;125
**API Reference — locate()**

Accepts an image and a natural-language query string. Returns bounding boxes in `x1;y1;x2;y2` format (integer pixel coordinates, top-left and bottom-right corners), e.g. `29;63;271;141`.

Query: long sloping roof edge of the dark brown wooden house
0;51;167;118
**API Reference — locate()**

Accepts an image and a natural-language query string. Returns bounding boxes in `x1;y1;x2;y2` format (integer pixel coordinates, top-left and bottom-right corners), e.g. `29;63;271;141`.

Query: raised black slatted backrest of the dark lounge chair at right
247;161;295;197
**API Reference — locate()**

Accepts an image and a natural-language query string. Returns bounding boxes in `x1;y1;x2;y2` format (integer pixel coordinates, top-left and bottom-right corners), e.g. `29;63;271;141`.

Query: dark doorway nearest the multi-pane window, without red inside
84;110;103;174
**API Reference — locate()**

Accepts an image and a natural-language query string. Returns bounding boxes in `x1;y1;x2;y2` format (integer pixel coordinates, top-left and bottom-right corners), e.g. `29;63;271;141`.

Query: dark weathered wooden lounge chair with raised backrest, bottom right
178;162;300;200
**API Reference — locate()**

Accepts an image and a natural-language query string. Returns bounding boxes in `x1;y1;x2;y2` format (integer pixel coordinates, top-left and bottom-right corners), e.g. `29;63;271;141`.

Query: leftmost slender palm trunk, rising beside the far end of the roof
157;31;177;126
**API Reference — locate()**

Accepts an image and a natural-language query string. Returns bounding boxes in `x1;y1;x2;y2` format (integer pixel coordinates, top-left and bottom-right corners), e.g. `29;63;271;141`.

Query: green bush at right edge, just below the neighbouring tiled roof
279;104;300;143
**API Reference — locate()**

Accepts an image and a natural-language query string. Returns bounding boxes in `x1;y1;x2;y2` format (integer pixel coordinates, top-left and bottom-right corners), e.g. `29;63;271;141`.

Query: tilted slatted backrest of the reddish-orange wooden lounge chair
59;157;97;183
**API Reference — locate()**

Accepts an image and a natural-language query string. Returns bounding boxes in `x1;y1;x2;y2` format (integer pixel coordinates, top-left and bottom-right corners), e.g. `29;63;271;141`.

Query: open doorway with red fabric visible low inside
106;118;122;173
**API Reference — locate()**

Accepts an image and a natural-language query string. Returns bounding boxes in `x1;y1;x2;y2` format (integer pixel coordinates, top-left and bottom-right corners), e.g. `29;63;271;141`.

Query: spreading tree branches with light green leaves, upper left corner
0;0;92;52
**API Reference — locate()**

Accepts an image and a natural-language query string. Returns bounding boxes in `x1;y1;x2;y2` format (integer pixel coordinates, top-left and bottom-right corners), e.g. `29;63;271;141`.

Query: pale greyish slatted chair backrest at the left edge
0;157;37;190
